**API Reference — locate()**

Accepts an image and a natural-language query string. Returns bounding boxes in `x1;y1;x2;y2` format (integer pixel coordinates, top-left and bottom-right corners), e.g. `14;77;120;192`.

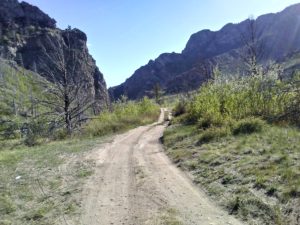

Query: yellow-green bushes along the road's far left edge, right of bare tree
84;97;159;136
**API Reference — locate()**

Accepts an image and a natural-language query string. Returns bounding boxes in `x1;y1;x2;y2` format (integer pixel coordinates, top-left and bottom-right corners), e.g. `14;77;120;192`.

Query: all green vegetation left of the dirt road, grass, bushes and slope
0;61;160;225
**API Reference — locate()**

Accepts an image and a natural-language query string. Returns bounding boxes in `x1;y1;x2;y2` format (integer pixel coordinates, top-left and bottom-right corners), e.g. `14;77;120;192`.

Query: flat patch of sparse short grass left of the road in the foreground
0;138;108;225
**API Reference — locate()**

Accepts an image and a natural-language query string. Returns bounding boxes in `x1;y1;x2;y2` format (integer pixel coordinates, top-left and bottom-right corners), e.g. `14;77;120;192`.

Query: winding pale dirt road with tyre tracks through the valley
82;110;242;225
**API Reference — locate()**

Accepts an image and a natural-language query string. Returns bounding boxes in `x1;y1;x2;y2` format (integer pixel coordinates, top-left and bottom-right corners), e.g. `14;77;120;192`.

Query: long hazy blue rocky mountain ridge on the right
109;4;300;99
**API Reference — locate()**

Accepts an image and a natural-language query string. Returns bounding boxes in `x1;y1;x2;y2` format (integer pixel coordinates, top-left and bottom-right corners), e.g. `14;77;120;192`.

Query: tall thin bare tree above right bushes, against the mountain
240;17;265;76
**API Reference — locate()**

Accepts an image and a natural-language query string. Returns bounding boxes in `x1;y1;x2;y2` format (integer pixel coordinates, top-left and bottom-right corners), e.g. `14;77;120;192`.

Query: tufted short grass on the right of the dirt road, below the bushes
163;124;300;225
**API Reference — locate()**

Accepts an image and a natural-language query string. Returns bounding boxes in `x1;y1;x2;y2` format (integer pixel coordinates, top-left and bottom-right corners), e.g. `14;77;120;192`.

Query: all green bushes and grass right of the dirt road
163;71;300;225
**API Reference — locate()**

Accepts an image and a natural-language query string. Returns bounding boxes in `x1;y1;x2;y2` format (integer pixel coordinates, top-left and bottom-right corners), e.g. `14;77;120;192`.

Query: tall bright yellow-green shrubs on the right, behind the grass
188;71;300;125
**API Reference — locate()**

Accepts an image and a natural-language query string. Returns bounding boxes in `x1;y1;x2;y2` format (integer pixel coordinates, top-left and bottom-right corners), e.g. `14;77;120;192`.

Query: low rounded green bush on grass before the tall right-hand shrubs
232;118;266;135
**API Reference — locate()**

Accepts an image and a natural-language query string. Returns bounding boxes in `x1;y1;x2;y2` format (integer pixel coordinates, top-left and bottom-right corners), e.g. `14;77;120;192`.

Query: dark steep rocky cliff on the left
0;0;109;113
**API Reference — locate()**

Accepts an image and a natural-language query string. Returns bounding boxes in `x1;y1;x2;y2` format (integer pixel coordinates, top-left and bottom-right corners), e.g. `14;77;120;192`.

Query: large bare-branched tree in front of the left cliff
39;29;94;135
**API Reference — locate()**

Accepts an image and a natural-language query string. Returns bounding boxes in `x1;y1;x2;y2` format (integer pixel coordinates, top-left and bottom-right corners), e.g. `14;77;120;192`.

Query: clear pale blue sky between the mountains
25;0;300;87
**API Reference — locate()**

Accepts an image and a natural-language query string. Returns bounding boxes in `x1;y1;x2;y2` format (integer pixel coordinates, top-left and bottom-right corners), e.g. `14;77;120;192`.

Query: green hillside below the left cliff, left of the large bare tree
0;60;48;145
